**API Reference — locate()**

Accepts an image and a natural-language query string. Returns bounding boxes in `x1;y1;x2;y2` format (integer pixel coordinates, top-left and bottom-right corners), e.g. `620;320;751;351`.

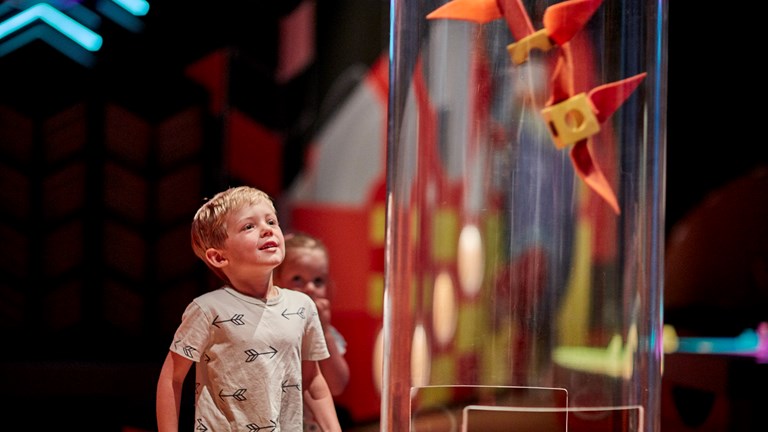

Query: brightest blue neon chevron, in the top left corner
0;3;102;51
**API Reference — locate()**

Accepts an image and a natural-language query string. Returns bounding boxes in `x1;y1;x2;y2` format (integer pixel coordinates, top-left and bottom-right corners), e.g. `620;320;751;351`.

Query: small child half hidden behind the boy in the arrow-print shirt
274;233;349;432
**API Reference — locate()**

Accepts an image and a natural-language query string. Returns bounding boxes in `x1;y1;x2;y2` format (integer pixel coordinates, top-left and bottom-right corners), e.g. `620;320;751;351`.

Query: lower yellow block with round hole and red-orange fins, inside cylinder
541;93;600;149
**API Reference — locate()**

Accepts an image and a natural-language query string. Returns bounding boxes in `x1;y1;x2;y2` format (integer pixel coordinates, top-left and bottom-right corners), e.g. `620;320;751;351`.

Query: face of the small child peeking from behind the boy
278;248;329;299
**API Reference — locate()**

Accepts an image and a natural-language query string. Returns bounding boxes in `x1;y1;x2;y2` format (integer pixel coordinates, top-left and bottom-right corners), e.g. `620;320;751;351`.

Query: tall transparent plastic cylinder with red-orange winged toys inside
381;0;667;432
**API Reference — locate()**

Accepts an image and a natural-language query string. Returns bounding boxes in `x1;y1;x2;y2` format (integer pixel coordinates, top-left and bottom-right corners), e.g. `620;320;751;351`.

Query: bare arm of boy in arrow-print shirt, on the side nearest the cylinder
301;361;341;432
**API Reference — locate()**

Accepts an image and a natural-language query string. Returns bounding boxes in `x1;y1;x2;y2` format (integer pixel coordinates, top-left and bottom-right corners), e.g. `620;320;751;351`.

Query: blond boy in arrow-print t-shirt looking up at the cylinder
157;186;341;432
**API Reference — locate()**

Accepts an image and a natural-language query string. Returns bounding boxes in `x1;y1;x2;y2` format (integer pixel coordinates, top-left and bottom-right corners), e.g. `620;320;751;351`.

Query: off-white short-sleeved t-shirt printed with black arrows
170;287;329;432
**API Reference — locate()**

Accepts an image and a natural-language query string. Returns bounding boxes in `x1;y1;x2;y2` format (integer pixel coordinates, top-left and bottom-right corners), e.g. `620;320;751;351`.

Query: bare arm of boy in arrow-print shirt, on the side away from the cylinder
155;351;193;432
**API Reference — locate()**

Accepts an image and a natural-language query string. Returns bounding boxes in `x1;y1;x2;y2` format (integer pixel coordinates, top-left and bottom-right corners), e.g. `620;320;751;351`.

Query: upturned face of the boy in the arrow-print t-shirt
214;201;285;272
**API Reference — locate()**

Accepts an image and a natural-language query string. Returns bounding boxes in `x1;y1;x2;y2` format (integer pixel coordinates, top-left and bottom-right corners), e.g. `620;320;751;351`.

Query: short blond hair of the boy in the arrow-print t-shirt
191;186;275;281
